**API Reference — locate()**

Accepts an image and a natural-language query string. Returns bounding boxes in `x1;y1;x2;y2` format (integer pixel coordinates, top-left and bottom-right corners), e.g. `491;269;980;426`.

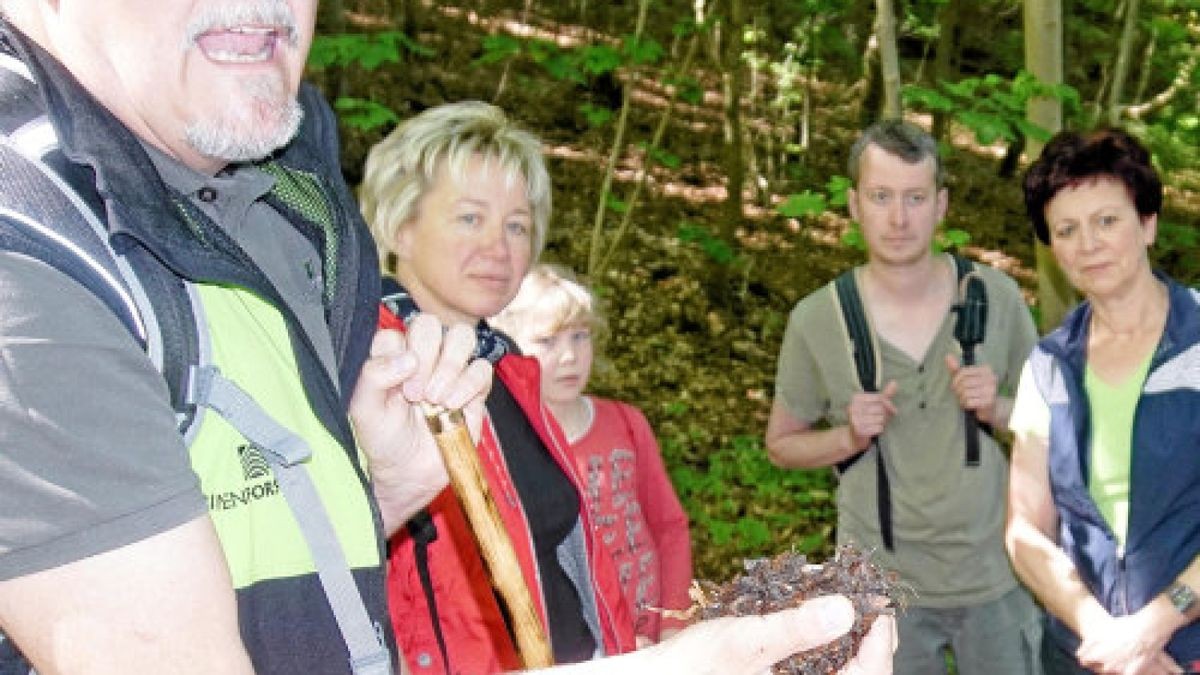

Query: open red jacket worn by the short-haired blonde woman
379;309;635;675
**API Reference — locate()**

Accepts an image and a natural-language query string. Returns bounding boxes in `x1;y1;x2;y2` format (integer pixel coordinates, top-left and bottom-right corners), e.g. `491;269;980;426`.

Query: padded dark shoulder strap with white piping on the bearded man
0;52;199;429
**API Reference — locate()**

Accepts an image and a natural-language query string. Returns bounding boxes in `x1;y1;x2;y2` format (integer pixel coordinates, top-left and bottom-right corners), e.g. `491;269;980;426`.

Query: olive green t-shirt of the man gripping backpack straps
775;255;1037;608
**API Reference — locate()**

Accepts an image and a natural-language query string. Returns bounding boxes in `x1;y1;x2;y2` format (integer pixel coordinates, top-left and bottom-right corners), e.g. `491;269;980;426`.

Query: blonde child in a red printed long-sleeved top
490;264;691;644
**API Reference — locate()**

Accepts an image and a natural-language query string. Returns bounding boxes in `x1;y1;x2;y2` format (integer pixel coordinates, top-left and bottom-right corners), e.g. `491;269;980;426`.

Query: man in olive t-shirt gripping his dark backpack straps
767;120;1040;675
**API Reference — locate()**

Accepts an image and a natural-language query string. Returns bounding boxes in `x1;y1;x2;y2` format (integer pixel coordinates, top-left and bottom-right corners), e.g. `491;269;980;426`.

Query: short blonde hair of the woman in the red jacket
359;101;551;271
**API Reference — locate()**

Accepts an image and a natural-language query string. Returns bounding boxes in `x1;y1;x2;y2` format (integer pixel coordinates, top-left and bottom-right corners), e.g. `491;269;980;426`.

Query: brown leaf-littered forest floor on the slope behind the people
328;6;1196;579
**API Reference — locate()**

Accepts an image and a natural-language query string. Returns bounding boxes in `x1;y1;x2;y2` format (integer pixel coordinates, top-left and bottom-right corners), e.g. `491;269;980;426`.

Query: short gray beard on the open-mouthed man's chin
187;89;304;162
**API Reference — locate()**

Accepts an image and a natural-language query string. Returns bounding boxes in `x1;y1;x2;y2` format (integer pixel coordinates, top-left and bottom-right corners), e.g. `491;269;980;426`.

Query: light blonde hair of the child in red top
488;263;607;342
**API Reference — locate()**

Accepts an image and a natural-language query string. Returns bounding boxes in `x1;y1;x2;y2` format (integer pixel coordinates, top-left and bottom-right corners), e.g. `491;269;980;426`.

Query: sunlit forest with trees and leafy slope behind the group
310;0;1200;580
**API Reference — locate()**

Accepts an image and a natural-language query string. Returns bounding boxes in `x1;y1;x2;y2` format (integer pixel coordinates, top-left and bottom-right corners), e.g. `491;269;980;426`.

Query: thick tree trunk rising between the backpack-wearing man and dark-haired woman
1025;0;1075;333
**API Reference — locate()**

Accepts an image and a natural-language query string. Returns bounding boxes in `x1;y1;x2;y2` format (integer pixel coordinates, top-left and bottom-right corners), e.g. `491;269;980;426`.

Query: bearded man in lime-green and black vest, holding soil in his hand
0;0;889;675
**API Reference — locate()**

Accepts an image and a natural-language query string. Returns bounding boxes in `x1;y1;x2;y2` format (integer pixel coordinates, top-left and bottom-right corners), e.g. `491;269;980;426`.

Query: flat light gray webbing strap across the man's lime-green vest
187;365;391;675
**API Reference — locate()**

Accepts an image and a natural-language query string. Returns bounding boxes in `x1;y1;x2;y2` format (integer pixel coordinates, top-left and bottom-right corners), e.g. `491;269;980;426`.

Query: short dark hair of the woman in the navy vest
1025;129;1163;244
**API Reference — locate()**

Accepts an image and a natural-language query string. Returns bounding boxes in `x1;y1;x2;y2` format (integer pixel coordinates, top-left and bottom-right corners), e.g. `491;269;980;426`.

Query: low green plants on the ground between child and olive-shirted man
664;436;836;575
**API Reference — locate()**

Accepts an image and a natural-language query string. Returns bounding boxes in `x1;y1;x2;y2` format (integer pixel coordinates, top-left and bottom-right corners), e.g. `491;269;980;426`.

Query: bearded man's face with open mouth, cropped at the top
50;0;317;173
